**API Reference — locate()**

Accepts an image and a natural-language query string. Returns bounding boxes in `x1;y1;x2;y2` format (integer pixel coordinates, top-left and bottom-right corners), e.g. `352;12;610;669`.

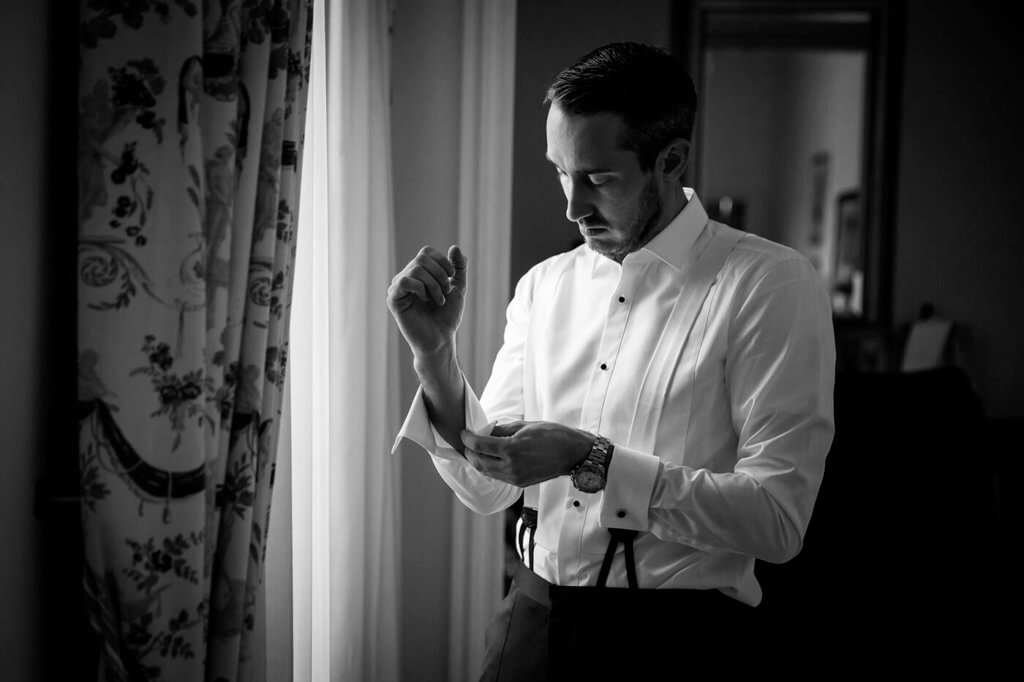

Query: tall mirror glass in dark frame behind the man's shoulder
698;47;867;315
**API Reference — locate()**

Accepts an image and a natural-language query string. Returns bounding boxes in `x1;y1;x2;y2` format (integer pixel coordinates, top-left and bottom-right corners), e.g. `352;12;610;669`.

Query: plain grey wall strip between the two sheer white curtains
389;0;462;682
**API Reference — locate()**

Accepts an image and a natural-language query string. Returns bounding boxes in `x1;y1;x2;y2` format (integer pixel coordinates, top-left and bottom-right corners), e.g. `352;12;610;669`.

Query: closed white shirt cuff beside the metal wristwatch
599;445;662;530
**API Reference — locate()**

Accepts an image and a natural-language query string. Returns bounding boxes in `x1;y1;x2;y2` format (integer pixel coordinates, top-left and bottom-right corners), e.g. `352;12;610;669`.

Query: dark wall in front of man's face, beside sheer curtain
510;0;672;287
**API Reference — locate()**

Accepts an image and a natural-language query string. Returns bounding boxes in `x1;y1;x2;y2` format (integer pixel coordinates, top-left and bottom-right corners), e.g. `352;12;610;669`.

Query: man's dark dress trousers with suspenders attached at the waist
480;507;757;682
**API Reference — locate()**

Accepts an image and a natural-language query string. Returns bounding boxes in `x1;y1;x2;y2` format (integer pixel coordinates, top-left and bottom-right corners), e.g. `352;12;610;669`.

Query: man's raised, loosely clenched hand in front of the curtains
387;246;467;356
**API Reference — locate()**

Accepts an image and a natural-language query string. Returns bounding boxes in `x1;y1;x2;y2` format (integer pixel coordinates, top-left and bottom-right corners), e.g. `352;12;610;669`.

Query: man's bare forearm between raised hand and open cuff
413;345;466;455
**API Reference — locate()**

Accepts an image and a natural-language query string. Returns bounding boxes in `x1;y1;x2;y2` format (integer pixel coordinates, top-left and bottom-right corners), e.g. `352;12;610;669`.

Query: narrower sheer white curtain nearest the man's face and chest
449;0;516;681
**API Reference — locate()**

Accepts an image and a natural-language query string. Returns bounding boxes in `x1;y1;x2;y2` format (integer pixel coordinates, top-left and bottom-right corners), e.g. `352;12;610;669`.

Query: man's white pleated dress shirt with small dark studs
395;188;836;605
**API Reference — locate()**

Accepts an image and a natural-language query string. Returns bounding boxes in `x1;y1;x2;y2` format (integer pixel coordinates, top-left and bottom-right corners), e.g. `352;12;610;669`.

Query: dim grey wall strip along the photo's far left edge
0;3;49;680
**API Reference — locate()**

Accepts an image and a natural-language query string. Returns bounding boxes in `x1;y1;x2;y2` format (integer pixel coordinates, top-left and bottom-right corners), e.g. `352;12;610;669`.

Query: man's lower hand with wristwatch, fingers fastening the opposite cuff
462;422;596;487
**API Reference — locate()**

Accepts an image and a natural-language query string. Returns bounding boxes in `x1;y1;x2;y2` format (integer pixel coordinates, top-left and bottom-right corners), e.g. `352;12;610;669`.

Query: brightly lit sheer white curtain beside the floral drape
290;0;400;682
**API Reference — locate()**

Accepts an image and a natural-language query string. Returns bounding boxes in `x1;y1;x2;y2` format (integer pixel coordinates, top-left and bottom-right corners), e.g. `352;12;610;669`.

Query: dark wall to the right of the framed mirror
893;0;1024;417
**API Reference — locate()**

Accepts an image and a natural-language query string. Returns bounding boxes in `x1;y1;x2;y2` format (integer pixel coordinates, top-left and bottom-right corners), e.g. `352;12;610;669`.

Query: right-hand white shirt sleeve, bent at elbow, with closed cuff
601;259;836;563
